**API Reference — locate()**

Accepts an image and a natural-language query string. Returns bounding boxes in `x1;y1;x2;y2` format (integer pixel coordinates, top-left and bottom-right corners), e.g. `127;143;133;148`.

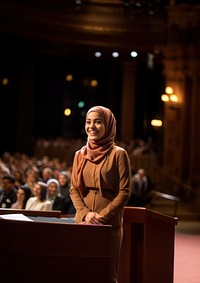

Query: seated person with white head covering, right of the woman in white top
47;179;75;214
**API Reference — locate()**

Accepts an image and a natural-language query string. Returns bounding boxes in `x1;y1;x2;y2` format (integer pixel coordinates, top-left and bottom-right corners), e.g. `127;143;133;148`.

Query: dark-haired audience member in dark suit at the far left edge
0;175;17;208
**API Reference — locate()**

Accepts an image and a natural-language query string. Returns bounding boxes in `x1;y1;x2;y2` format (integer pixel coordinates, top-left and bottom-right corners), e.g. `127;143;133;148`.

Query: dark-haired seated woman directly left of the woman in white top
11;185;31;209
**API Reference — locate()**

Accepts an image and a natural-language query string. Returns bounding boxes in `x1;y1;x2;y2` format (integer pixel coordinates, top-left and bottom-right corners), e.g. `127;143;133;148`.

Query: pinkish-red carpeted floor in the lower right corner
174;222;200;283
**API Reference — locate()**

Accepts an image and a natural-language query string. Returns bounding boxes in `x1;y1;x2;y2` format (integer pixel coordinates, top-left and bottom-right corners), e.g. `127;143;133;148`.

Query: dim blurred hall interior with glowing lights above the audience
0;0;200;217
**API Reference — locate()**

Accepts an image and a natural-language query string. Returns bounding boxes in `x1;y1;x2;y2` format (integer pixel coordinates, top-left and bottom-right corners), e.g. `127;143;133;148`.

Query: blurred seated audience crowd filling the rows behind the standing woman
0;137;154;214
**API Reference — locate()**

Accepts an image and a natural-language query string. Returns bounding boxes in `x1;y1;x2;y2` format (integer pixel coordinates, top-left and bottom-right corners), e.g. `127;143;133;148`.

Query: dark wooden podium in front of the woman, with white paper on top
0;211;111;283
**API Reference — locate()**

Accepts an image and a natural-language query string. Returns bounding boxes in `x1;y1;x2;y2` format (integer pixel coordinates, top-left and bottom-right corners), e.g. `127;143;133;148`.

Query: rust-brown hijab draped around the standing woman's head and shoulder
74;106;116;195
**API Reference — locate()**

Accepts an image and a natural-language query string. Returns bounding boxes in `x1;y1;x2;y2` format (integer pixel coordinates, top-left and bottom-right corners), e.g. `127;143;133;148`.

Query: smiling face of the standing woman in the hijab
85;112;106;140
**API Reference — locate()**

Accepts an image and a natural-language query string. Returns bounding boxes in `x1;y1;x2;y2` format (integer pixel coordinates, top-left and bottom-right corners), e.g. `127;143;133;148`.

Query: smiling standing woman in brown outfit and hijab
70;106;131;282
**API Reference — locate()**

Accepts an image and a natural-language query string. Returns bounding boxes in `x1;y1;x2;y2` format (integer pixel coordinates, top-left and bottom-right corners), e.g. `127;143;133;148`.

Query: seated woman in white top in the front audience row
25;182;52;210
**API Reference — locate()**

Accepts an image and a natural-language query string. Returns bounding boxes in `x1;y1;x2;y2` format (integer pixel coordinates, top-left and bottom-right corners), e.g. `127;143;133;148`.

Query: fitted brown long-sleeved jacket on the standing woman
70;146;131;227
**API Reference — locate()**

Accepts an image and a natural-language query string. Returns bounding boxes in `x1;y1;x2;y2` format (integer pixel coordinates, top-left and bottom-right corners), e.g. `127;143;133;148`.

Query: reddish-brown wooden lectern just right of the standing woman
119;207;177;283
